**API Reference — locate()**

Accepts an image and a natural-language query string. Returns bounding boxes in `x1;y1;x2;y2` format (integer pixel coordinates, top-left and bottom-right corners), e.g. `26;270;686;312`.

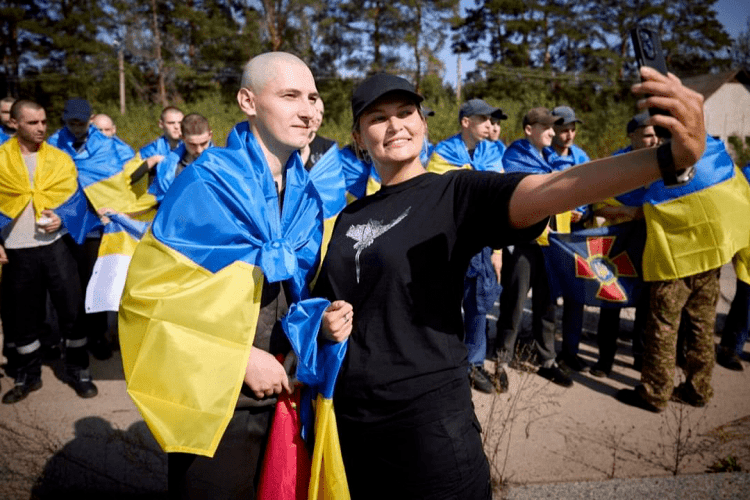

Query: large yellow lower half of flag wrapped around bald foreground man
120;232;263;457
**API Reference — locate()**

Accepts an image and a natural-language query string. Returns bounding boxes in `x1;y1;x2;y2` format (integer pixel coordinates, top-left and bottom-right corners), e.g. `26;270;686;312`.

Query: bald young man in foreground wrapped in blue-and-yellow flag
120;52;336;499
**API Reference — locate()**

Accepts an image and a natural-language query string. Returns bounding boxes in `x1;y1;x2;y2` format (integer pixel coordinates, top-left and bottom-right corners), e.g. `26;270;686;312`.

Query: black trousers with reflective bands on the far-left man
0;237;88;377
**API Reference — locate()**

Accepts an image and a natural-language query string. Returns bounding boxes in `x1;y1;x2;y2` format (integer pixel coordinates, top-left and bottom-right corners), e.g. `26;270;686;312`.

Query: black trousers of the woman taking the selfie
334;378;492;500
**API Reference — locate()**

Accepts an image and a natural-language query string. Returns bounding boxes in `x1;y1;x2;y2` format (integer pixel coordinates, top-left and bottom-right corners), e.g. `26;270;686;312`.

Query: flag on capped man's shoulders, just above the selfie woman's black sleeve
428;133;503;174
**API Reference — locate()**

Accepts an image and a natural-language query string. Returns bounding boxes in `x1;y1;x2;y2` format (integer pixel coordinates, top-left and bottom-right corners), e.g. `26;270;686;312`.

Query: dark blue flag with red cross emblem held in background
542;221;646;307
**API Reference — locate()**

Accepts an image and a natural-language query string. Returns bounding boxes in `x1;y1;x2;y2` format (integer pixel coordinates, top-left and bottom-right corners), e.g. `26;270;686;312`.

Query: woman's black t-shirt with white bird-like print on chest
315;170;546;421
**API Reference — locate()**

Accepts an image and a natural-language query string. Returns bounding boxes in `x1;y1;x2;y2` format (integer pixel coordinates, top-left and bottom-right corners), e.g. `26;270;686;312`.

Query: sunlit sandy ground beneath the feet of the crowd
0;266;750;500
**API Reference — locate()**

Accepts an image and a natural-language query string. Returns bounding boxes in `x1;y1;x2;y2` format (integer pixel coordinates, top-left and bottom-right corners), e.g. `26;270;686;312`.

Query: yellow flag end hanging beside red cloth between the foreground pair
308;394;350;500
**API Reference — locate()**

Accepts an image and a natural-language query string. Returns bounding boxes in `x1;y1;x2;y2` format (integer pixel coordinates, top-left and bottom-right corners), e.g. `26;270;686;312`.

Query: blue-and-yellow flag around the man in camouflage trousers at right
617;136;750;281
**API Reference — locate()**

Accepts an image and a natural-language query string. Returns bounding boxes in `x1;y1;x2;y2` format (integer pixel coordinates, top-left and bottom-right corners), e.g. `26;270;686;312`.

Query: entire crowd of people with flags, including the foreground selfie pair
0;48;750;499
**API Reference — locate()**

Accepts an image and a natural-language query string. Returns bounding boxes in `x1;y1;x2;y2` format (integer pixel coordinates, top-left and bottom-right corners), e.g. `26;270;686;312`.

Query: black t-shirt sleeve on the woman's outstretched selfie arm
446;170;548;248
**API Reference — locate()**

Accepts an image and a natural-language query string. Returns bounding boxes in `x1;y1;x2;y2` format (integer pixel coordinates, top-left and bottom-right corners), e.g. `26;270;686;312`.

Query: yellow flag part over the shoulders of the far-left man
0;137;78;219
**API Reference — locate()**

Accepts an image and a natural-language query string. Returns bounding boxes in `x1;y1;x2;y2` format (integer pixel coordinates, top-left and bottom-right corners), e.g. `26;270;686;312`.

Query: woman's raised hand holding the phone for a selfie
632;66;706;171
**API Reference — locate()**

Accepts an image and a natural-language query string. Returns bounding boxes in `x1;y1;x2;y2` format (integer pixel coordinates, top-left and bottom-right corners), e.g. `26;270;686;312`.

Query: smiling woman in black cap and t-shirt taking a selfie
315;69;705;500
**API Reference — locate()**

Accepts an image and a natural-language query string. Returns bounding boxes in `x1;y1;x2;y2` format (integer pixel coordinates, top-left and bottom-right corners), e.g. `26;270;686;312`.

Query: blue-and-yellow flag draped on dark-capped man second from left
49;125;143;212
